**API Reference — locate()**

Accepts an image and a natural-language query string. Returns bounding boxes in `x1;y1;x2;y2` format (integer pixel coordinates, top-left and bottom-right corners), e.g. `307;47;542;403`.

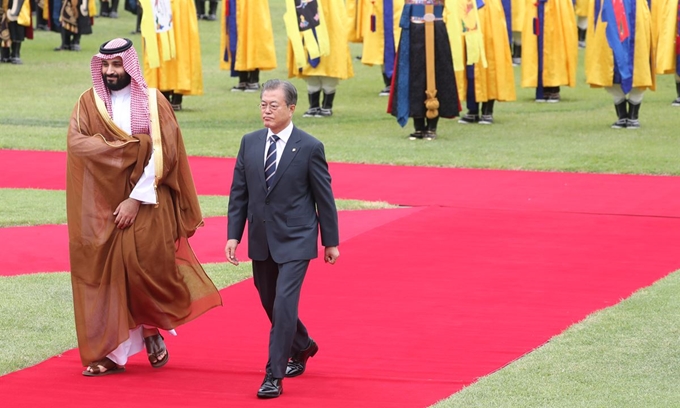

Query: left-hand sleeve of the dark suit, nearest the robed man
227;138;248;242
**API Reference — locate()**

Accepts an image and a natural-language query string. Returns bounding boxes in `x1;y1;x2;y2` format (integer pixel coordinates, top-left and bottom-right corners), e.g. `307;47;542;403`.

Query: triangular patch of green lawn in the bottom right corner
435;272;680;408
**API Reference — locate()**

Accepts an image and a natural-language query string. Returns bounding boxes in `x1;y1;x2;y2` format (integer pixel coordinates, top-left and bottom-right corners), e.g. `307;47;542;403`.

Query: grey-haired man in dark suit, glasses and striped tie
225;79;340;398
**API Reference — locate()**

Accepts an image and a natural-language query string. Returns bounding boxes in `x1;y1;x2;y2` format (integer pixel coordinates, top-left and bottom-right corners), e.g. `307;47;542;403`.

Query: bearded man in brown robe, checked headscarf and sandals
66;38;222;376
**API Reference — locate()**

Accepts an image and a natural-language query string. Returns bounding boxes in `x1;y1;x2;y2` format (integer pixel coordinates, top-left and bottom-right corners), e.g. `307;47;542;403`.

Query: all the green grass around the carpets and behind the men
0;2;680;408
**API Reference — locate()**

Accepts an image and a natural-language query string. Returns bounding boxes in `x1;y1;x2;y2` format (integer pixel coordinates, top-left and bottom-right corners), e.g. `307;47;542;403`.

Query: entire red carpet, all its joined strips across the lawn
0;150;680;408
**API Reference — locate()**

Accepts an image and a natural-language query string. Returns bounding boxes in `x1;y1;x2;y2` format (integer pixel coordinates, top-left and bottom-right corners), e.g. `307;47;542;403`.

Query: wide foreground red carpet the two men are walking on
0;208;680;408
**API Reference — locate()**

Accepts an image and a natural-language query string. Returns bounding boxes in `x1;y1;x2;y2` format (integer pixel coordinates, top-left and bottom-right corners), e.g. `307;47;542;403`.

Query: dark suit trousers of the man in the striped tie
253;254;311;378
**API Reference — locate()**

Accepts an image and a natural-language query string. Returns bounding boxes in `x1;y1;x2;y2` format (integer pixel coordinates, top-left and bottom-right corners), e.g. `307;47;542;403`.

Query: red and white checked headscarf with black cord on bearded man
90;38;151;135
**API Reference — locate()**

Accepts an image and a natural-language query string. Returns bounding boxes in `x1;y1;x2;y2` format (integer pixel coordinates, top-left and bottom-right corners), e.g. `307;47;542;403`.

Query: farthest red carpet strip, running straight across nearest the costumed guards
0;150;680;216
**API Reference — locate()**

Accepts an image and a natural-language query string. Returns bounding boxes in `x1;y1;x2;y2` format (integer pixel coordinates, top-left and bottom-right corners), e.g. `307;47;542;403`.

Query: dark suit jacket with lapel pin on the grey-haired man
227;127;340;263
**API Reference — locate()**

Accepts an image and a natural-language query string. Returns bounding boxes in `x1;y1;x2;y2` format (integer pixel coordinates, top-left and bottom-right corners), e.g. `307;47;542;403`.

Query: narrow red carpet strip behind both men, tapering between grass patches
0;208;420;276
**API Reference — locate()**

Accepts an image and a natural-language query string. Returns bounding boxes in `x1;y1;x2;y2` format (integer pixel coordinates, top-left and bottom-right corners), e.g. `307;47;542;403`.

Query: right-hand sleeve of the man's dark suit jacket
309;143;340;247
